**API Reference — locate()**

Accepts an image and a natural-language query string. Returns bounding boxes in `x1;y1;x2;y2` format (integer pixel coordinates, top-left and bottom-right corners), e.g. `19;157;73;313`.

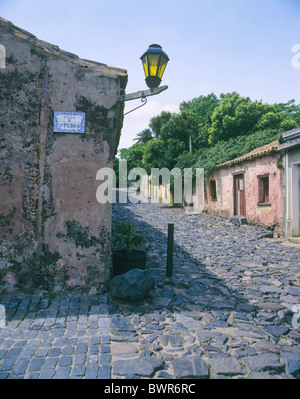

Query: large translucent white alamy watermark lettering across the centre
96;160;204;210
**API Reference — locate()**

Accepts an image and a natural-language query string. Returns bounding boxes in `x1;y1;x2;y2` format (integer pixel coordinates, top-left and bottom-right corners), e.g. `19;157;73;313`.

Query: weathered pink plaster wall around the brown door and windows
205;154;283;232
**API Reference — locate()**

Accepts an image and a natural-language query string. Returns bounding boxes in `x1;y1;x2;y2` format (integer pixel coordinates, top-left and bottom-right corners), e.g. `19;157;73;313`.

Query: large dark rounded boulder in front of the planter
109;269;154;301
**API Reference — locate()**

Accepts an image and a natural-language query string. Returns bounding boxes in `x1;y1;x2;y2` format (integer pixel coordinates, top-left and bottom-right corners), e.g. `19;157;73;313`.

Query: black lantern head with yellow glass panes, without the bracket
141;44;169;89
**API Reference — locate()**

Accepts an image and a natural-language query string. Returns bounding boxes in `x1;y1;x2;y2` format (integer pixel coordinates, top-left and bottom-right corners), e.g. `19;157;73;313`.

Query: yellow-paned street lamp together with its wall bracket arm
118;44;169;115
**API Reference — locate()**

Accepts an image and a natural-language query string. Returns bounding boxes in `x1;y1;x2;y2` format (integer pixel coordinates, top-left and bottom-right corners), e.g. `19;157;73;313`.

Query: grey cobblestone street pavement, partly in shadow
0;204;300;379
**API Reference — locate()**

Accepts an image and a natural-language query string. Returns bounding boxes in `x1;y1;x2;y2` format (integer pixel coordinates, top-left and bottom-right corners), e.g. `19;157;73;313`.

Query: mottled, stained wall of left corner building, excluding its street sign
0;19;127;293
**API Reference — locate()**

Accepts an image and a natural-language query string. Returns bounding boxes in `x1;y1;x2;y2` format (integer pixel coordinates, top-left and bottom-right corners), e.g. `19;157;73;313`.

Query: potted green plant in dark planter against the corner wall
113;221;146;276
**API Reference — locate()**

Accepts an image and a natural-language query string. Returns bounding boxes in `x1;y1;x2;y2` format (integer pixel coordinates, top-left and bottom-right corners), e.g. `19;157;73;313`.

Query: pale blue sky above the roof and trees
0;0;300;148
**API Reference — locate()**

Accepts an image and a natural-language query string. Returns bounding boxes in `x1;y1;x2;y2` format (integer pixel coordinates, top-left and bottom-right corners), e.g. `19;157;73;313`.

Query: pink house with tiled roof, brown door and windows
200;141;283;233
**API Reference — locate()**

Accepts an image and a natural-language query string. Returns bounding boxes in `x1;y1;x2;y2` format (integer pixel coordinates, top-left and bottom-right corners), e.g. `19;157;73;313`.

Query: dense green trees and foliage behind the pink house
114;92;300;180
